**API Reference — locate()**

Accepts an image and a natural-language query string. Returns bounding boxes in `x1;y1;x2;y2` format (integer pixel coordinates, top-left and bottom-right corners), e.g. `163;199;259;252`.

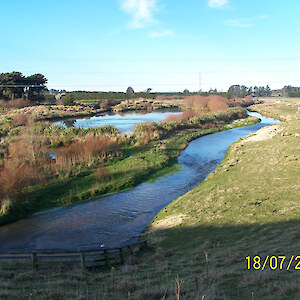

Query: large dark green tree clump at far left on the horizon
0;72;48;102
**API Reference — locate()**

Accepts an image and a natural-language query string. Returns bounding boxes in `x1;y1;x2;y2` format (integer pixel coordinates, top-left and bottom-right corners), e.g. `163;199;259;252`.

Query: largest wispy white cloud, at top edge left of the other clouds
121;0;158;28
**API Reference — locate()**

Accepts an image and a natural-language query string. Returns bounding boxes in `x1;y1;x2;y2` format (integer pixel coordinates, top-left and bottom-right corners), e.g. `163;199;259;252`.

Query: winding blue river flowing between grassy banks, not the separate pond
0;113;279;250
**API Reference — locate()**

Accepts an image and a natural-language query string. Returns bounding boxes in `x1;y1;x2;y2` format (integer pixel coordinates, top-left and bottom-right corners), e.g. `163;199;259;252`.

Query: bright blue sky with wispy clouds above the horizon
0;0;300;91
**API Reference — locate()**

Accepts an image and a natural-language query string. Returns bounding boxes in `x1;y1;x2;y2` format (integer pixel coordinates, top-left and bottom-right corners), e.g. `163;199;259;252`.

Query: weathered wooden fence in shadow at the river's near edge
0;241;148;270
